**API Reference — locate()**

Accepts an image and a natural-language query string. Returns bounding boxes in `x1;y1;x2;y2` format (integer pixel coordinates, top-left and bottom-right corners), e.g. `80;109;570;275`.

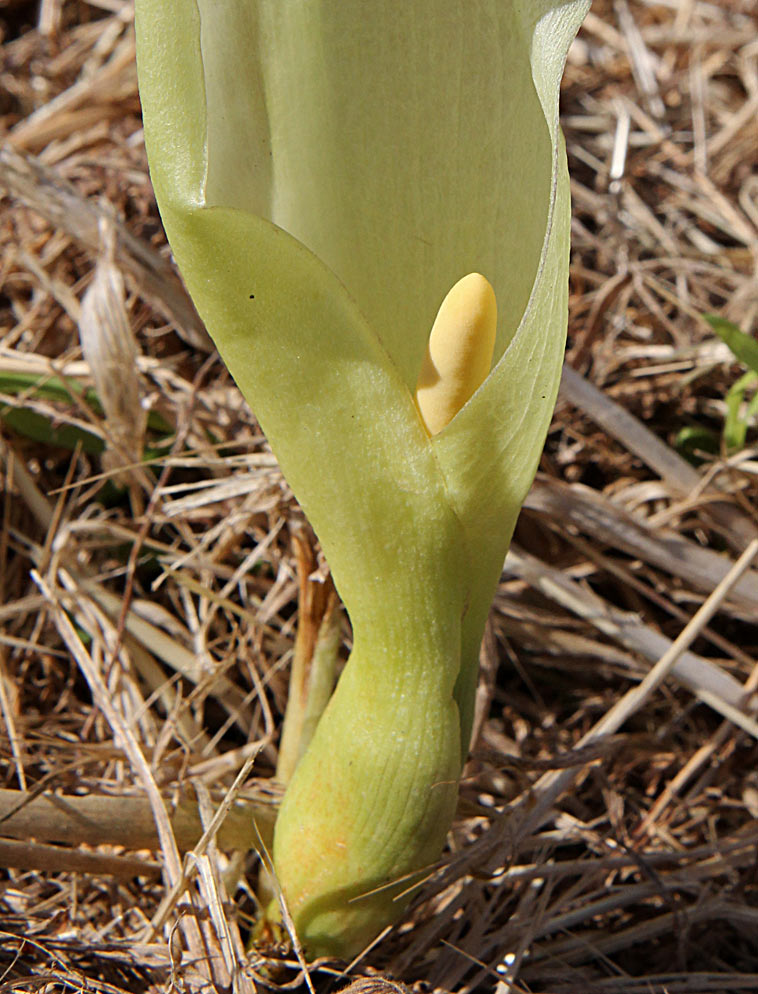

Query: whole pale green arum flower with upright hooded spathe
136;0;587;956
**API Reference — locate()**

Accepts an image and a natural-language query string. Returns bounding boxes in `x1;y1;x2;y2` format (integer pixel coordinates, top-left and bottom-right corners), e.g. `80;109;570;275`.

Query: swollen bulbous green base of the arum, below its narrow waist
269;626;461;957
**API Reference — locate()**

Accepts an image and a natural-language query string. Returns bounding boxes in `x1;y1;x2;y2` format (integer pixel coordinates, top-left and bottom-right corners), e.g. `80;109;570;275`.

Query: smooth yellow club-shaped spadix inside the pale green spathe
416;273;497;435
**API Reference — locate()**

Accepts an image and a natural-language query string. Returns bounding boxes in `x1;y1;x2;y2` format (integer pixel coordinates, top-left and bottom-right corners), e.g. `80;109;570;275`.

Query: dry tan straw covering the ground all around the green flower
0;0;758;994
